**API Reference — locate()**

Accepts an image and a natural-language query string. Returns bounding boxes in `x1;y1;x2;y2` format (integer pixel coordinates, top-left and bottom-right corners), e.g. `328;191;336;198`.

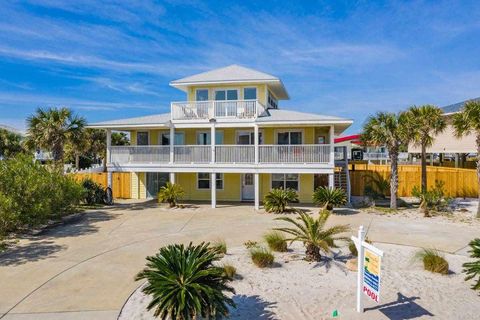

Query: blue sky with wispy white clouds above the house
0;0;480;133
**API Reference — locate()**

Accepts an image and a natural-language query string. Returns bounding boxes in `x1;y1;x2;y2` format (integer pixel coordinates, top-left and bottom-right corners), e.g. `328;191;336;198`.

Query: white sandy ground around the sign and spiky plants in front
119;244;480;320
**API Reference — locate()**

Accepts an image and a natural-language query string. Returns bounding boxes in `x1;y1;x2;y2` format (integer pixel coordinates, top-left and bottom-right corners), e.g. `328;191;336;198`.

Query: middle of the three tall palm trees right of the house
407;104;447;192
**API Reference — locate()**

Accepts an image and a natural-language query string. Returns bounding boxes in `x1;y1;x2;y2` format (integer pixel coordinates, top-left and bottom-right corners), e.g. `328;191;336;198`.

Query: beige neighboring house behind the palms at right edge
408;98;480;167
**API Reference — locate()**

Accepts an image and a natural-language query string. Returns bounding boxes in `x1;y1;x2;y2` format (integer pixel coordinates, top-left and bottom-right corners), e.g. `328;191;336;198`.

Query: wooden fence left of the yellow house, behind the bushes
73;172;131;199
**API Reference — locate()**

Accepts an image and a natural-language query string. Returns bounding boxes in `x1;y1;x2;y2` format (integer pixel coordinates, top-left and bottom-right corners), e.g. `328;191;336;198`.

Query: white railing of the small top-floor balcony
171;100;265;120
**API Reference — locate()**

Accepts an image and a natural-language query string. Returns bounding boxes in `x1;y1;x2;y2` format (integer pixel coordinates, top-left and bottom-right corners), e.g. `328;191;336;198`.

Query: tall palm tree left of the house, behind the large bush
27;108;86;162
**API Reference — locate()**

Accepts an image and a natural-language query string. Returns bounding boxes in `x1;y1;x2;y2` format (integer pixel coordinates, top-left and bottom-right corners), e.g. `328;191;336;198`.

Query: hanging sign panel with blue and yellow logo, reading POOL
363;248;382;302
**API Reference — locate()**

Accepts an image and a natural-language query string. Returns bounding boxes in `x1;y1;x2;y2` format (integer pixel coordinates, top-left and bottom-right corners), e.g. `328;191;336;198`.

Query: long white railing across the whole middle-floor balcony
110;144;330;164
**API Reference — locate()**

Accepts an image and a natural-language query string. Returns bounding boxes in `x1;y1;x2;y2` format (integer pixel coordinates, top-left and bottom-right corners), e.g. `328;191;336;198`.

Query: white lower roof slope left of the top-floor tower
87;113;170;129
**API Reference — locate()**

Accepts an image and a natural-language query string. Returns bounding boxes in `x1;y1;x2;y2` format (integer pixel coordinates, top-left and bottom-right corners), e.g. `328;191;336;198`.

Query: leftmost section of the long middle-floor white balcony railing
110;146;170;163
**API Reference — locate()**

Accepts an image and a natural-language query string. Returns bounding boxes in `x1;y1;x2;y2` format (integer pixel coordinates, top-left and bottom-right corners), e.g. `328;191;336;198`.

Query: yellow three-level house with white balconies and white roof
89;65;352;208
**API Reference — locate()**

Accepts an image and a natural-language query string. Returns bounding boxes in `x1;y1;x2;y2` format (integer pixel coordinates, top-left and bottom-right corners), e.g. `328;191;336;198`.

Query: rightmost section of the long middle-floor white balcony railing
259;144;330;163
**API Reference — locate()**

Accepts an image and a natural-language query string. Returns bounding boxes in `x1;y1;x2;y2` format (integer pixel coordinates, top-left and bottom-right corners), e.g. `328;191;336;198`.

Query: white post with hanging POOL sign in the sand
352;226;383;313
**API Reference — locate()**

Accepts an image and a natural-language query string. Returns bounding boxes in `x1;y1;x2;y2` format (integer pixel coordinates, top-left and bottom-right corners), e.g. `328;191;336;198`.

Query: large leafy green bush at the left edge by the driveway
0;154;84;236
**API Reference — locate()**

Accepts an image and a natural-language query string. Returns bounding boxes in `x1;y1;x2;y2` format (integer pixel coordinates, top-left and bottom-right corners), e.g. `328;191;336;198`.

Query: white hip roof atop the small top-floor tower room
170;64;289;99
